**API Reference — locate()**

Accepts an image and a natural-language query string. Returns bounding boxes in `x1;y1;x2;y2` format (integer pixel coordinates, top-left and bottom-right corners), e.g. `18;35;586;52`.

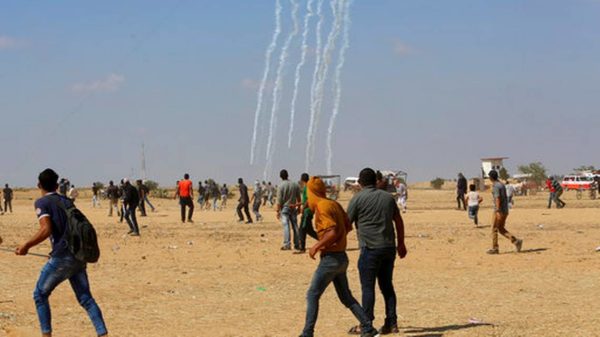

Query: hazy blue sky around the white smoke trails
0;0;600;186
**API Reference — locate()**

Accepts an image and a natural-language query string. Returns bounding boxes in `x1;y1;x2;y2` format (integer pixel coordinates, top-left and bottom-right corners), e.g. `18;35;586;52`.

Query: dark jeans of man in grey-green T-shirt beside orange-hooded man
358;247;398;326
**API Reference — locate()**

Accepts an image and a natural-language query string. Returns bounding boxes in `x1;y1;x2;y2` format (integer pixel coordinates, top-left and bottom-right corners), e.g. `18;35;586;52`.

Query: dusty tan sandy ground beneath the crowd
0;190;600;337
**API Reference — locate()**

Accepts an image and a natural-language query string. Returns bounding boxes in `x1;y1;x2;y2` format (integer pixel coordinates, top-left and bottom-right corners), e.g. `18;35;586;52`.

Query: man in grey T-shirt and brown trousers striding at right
487;170;523;254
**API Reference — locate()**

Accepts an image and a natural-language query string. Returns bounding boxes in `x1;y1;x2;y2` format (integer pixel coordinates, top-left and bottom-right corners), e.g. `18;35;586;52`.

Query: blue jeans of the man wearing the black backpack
33;255;107;336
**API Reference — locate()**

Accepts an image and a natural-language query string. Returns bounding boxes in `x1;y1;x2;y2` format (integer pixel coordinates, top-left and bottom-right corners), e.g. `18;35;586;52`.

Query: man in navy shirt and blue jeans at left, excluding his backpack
15;169;108;337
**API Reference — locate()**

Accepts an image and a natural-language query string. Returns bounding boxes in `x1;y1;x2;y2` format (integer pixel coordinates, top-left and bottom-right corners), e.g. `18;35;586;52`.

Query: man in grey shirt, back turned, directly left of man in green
277;170;300;251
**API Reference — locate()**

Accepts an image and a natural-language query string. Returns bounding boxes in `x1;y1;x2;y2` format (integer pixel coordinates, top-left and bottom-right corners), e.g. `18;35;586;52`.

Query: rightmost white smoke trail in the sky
327;0;352;174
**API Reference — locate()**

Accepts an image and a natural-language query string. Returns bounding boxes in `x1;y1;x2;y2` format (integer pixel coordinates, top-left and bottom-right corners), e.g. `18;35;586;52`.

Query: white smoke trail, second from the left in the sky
264;0;300;176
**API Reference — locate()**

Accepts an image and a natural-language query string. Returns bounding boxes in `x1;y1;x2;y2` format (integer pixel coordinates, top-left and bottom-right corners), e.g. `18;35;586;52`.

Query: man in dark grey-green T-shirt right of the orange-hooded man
348;168;407;335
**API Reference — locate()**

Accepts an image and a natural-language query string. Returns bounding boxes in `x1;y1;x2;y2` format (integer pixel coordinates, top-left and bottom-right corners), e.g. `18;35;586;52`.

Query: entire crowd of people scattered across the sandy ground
0;168;600;337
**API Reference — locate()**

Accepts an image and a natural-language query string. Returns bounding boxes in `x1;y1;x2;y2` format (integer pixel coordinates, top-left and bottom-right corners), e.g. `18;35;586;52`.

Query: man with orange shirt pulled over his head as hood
300;177;378;337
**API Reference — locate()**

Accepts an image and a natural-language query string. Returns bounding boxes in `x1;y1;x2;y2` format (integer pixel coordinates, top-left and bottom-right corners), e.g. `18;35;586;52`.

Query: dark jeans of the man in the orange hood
302;252;373;337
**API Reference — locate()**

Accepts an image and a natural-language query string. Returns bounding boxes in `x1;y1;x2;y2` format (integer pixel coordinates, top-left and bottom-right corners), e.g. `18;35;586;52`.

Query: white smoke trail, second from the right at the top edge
306;0;343;167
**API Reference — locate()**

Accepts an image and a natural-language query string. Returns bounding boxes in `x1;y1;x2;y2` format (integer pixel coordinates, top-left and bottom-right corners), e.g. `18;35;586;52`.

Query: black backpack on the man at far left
56;197;100;263
